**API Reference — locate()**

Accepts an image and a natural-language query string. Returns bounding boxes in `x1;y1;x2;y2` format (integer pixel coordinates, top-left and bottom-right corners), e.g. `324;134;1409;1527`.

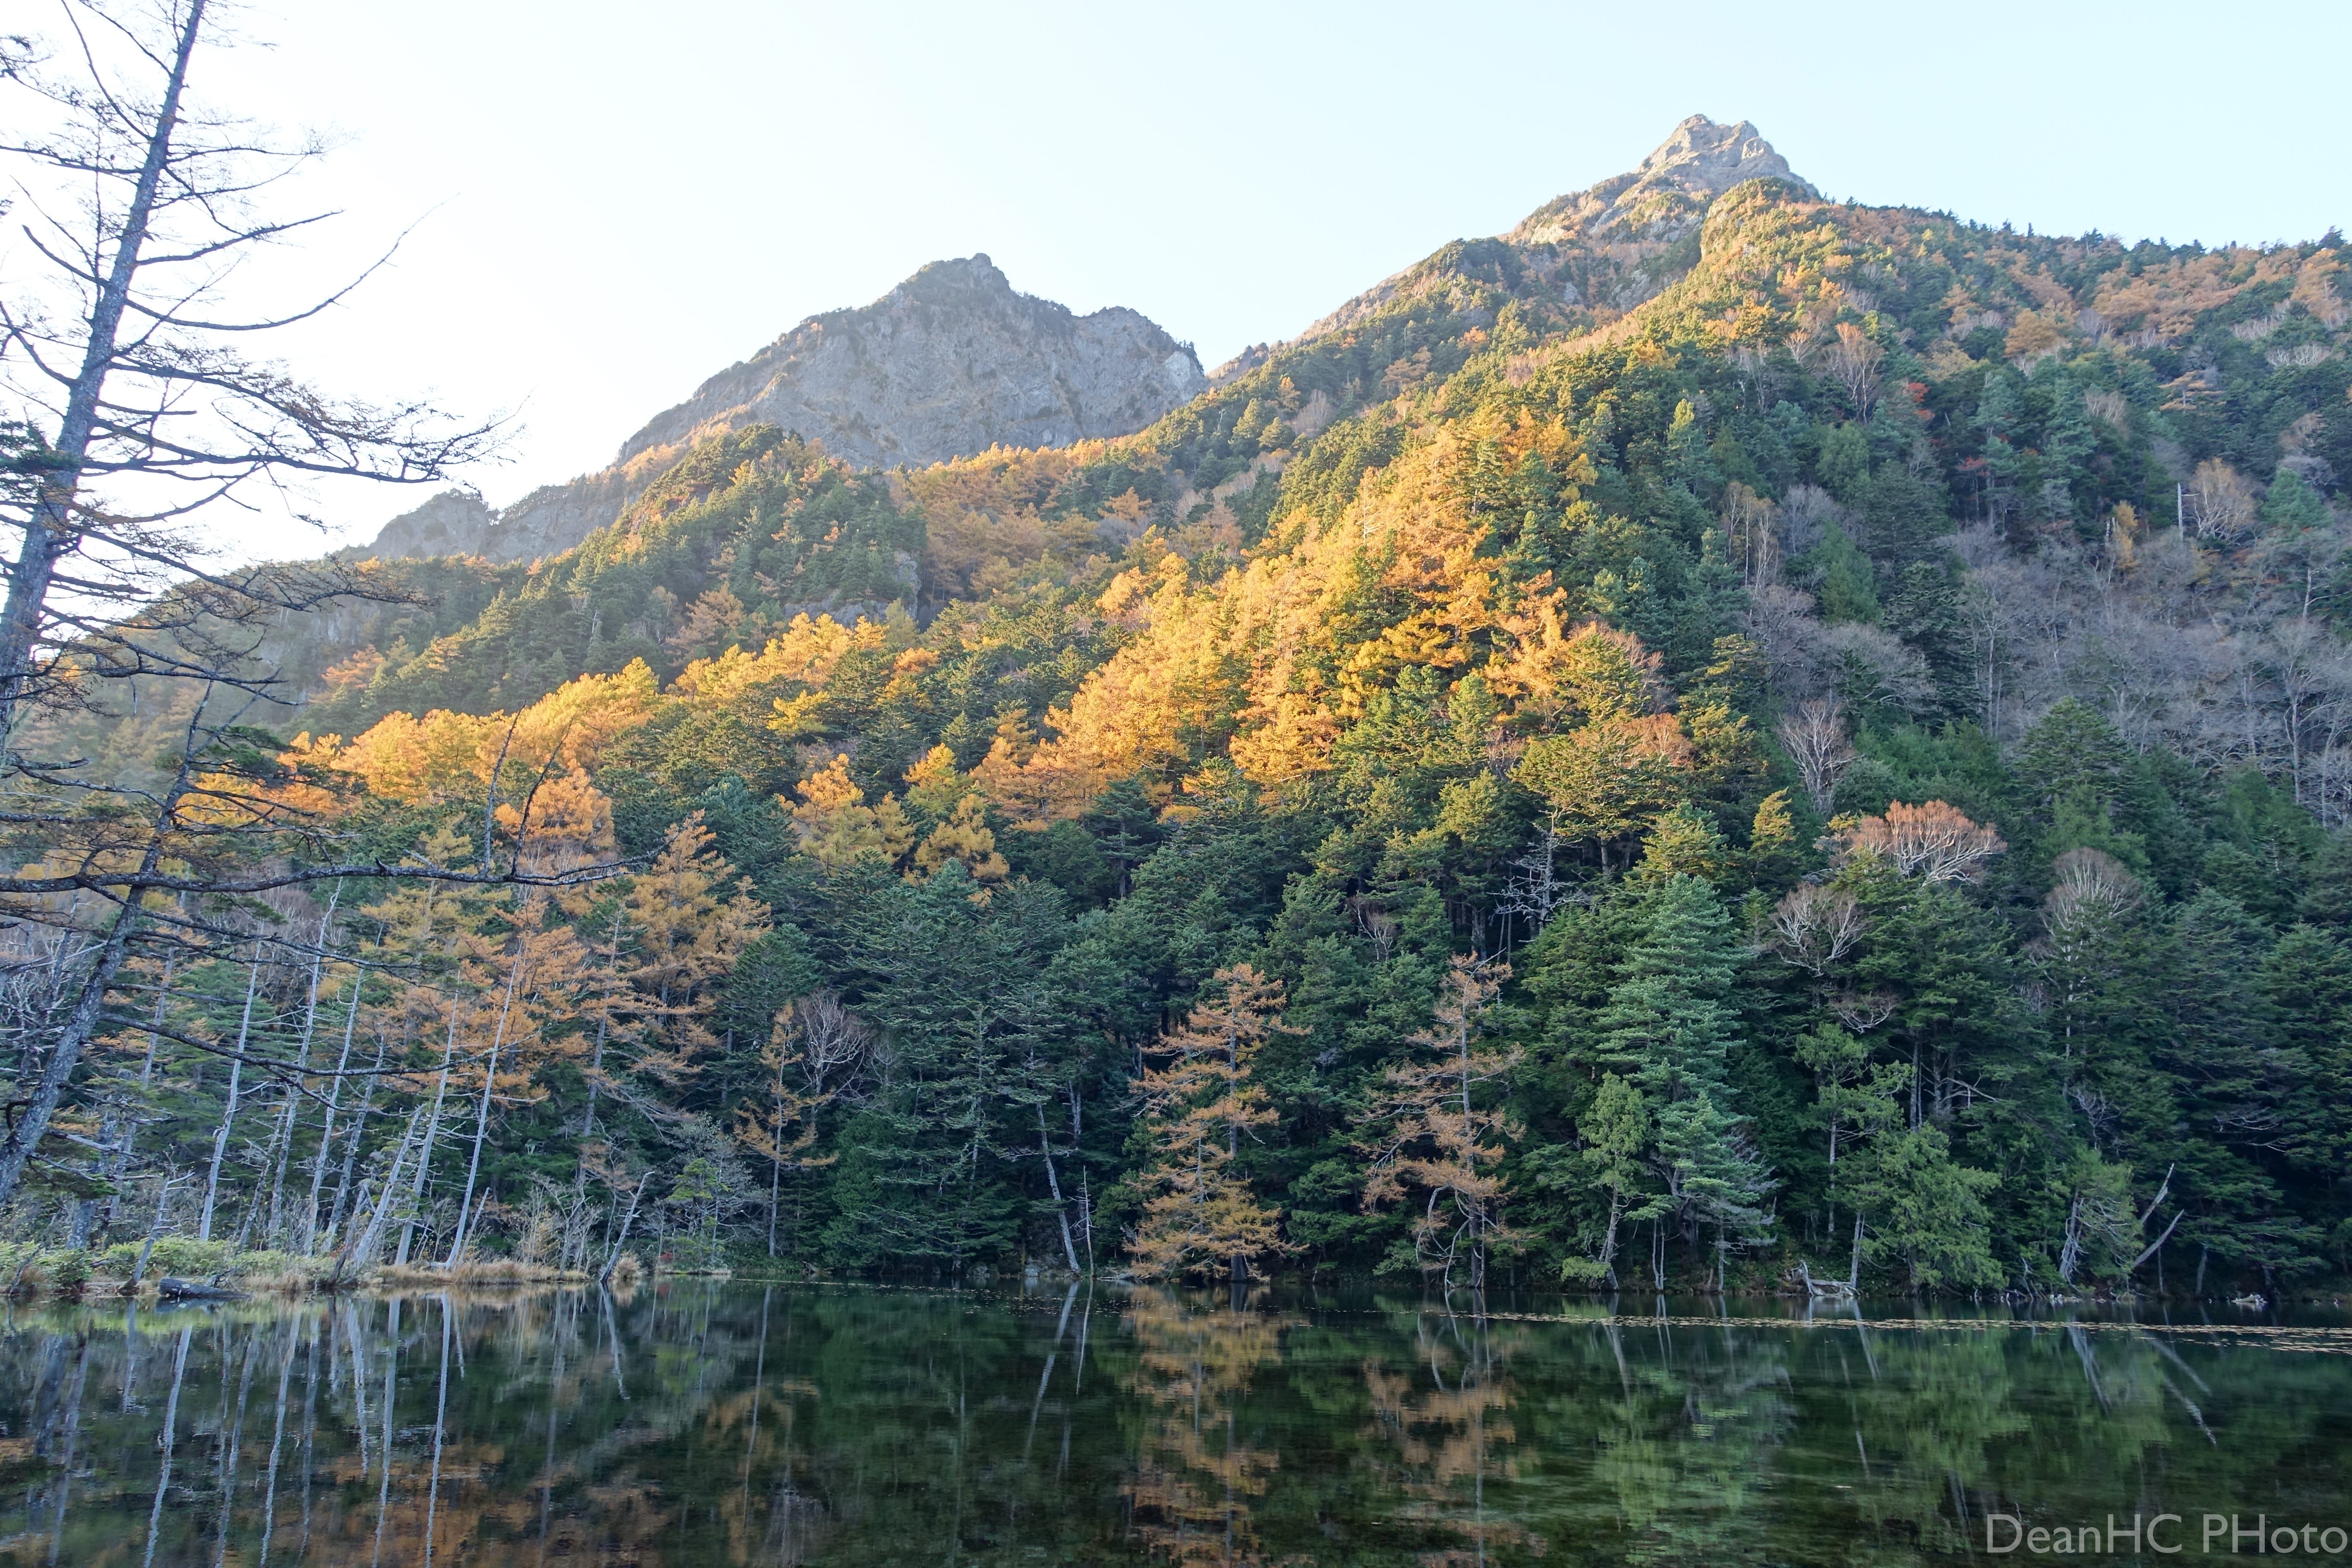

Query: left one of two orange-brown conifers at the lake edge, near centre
1129;964;1296;1279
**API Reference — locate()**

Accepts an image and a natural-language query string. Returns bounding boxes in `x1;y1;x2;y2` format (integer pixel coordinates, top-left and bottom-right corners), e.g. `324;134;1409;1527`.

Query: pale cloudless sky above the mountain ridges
151;0;2352;548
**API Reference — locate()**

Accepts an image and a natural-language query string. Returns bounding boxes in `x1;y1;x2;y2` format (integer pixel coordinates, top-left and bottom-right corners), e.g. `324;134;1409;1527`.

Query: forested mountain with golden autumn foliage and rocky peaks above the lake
92;117;2352;1293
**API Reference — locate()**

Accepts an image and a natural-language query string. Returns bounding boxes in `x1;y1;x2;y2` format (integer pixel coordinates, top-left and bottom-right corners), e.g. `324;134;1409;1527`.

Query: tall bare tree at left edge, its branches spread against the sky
0;0;499;738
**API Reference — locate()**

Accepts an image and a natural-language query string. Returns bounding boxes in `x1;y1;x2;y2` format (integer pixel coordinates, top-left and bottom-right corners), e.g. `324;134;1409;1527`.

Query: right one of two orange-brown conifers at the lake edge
1357;955;1524;1291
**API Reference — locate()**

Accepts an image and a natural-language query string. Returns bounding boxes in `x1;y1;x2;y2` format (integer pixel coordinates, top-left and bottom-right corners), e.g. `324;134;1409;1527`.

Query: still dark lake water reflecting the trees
0;1281;2352;1568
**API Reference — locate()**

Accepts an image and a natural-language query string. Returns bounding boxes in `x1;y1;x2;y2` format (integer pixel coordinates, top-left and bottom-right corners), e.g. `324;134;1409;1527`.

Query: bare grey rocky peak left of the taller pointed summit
369;256;1207;560
